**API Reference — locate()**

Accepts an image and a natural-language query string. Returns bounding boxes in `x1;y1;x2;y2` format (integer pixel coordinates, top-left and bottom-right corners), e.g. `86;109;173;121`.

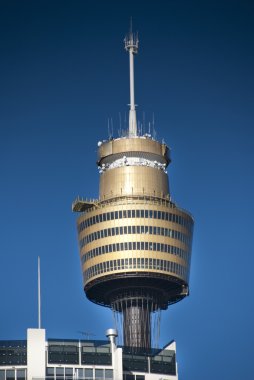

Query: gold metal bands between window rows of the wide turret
77;196;193;296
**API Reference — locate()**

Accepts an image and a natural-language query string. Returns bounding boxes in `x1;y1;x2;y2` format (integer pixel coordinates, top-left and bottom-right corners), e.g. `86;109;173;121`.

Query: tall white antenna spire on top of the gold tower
124;19;139;137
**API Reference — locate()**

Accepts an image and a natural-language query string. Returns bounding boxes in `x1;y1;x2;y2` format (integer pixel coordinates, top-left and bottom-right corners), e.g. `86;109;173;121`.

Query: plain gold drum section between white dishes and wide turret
100;166;169;200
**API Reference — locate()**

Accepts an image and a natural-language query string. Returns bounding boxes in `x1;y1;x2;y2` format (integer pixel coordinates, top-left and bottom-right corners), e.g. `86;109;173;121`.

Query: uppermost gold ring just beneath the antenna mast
98;137;170;165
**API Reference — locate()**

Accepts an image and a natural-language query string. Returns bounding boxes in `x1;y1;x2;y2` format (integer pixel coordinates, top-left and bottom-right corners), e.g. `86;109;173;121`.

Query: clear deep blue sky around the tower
0;0;254;380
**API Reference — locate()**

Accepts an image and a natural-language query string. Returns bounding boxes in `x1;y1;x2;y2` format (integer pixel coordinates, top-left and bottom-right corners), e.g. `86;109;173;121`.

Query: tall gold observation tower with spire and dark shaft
72;31;193;350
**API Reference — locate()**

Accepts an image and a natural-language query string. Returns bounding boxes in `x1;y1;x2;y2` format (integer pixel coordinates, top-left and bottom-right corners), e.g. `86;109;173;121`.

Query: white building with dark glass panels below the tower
0;329;178;380
